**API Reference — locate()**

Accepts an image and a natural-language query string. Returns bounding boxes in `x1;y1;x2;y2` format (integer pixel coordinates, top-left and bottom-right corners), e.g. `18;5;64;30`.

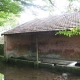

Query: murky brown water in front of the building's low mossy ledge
0;63;80;80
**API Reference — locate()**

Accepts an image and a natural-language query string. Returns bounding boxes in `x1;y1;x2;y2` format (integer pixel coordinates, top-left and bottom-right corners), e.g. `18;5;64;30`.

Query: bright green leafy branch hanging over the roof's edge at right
55;26;80;37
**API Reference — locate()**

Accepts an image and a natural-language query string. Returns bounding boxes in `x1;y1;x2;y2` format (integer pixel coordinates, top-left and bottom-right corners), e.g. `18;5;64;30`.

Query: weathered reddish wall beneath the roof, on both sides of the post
5;33;80;60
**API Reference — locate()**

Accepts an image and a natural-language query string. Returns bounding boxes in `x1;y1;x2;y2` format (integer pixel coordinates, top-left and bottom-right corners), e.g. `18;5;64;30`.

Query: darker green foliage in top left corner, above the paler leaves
0;0;22;14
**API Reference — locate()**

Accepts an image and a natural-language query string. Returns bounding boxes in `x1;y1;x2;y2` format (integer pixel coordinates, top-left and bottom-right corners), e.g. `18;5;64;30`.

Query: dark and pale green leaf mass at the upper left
0;0;23;26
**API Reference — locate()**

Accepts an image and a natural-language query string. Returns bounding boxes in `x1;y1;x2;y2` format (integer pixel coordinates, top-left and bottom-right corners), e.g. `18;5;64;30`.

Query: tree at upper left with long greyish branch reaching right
0;0;52;26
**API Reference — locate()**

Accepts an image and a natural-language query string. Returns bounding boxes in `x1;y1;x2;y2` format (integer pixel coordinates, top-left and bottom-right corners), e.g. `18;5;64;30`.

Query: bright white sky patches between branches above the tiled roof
19;0;68;24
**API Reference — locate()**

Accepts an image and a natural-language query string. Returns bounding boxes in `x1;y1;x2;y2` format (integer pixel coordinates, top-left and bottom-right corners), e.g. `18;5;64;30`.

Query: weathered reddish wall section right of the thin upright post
39;35;80;60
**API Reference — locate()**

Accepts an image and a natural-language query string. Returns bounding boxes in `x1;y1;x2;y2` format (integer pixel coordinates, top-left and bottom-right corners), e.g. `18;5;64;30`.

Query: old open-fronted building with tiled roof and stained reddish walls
2;12;80;62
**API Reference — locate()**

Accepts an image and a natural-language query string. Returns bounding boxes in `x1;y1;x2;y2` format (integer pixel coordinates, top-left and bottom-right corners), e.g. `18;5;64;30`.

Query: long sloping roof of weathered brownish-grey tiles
3;12;80;34
